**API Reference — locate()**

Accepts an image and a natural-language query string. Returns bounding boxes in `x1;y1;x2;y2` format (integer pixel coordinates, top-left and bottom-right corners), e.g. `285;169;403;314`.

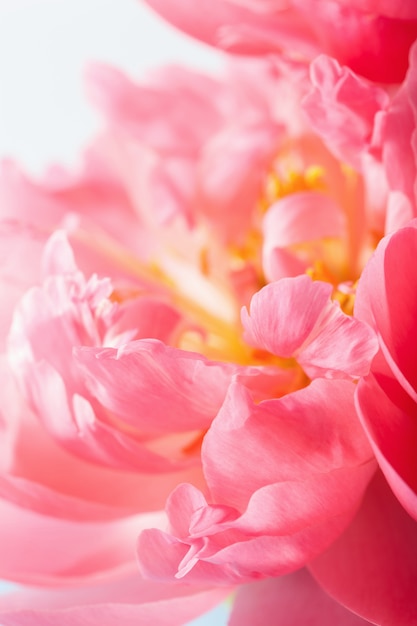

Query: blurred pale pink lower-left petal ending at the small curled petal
0;492;164;585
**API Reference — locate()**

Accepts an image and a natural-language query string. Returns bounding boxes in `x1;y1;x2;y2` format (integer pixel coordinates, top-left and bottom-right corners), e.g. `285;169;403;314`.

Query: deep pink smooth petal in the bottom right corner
310;474;417;626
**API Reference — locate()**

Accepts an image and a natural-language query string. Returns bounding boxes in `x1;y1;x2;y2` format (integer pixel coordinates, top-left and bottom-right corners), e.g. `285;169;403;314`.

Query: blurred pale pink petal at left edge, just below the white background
0;155;138;262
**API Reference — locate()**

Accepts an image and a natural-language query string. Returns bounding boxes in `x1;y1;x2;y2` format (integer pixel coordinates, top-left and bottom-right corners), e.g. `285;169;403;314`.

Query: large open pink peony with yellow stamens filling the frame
0;46;415;626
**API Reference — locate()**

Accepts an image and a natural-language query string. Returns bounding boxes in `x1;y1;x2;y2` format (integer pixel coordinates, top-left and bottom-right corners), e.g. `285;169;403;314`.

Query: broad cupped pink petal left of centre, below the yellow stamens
75;339;238;433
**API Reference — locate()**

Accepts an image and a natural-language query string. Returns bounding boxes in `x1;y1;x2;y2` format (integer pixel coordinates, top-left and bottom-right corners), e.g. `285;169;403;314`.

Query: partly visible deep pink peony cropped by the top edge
142;0;417;83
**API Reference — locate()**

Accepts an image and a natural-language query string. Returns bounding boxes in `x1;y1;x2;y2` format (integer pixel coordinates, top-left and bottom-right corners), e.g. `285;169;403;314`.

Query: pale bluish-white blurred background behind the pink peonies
0;0;227;626
